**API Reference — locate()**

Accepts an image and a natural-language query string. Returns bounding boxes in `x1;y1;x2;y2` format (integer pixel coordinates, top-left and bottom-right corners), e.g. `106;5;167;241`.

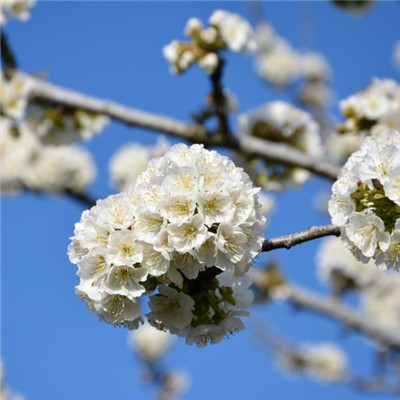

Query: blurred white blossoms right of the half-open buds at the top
256;22;332;107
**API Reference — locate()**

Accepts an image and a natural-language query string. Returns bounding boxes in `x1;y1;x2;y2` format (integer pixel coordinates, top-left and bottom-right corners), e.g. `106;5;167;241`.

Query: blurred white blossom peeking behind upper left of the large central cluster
109;137;169;191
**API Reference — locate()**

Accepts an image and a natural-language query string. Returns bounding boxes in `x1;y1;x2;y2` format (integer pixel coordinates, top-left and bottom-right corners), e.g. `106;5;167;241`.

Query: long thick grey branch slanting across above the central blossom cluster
23;72;340;180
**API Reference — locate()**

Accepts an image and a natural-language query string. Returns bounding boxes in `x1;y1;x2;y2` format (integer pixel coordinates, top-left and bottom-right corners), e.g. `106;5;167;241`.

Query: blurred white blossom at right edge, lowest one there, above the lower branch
361;273;400;332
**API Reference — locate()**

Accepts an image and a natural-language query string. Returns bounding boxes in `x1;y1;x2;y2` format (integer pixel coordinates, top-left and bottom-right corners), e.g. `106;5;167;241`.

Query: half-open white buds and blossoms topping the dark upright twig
163;10;256;74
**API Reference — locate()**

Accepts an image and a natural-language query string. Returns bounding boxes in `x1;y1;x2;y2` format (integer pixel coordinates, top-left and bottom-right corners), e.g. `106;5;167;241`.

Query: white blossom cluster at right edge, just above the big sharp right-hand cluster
338;78;400;135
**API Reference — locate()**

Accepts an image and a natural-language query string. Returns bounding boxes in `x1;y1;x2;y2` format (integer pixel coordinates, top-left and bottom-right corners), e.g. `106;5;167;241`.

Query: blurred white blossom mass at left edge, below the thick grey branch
0;117;96;194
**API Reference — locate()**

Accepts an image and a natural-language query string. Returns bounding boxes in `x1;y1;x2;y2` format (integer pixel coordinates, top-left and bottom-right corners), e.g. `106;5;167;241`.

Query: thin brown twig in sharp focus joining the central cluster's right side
262;225;340;251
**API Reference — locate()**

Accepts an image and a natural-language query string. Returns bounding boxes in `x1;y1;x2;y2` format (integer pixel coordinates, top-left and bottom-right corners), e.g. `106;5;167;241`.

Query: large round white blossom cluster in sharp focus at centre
68;144;265;346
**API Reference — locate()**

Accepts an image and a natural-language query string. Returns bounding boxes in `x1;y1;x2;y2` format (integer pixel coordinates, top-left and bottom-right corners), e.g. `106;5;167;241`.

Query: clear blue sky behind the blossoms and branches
1;1;400;400
